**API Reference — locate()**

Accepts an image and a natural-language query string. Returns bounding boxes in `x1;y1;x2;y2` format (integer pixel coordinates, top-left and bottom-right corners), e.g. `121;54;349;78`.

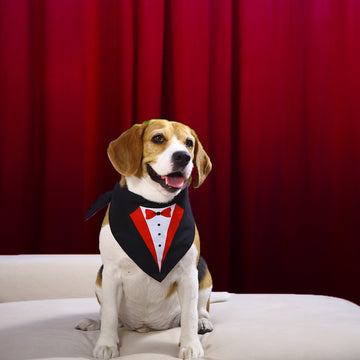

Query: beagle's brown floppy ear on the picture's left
108;124;147;176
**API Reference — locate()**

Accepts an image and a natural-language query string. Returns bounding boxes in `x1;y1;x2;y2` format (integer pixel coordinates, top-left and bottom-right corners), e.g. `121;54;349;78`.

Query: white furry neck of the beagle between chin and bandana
126;176;183;204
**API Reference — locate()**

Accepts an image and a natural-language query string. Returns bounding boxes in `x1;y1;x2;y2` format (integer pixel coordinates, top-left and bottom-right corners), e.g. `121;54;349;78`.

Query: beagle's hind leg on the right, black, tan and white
198;256;214;334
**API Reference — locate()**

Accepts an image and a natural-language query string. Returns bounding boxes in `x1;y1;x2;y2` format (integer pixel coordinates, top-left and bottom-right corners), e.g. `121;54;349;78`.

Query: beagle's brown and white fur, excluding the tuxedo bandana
77;120;213;359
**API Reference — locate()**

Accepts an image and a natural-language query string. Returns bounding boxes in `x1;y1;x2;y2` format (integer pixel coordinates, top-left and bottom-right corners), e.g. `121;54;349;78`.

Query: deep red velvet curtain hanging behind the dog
0;0;360;302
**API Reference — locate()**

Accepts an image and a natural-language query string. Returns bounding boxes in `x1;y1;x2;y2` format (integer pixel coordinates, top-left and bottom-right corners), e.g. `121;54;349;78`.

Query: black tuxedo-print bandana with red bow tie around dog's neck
86;183;195;281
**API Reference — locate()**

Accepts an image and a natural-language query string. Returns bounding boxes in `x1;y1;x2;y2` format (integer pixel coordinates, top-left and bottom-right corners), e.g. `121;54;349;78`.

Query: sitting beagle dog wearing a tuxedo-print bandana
77;119;213;359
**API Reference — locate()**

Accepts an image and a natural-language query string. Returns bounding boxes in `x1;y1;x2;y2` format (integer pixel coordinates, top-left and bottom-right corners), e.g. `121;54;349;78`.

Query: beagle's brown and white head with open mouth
108;120;212;202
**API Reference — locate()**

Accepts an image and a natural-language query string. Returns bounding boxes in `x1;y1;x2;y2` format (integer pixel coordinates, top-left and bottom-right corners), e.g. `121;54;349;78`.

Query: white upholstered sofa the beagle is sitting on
0;255;360;360
